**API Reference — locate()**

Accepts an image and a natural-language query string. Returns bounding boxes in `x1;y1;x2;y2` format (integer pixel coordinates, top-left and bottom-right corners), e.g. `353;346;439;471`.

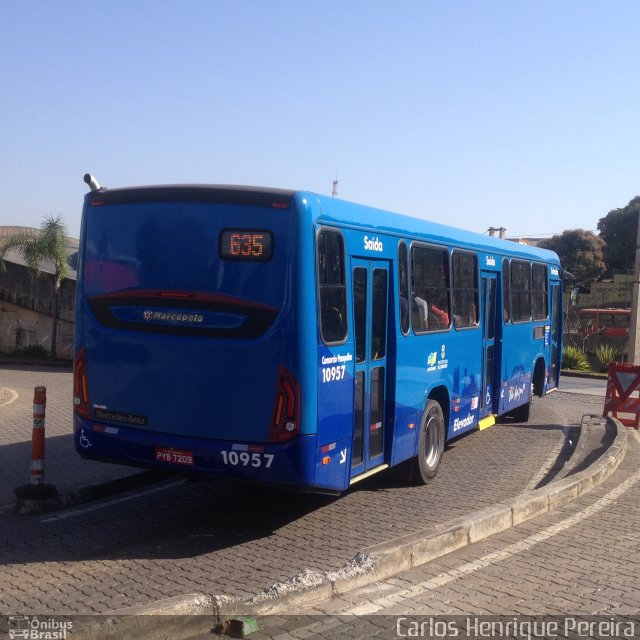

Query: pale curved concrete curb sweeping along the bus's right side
74;418;627;640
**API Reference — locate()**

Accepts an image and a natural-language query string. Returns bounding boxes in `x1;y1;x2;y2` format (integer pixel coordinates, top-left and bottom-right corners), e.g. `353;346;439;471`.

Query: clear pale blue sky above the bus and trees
0;0;640;237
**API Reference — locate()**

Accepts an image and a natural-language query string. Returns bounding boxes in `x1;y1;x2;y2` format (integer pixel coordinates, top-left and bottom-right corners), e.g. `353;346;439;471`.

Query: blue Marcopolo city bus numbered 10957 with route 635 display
74;176;562;493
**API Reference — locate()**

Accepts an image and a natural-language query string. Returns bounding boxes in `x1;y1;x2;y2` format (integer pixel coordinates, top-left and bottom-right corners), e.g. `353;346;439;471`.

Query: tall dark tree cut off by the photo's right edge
598;196;640;274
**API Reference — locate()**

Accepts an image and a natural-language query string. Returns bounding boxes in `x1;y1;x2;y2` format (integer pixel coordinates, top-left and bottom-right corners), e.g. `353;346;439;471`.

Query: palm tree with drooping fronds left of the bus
0;215;68;358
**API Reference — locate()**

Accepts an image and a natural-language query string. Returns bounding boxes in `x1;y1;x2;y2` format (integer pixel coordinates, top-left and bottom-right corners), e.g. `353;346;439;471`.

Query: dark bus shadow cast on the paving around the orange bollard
0;435;336;565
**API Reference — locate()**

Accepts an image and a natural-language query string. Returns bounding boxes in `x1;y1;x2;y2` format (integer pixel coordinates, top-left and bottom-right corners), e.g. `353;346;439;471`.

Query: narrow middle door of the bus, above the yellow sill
480;271;502;418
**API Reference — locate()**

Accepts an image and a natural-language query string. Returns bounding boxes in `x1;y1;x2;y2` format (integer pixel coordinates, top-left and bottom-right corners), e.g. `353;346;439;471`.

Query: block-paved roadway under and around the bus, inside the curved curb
0;369;602;614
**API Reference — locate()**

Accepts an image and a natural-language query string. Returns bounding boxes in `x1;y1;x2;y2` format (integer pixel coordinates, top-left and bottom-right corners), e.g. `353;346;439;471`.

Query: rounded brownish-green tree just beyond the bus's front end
539;229;605;289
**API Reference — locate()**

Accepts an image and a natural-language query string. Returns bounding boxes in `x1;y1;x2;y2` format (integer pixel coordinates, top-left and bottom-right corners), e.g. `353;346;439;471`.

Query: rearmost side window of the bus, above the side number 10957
318;230;347;344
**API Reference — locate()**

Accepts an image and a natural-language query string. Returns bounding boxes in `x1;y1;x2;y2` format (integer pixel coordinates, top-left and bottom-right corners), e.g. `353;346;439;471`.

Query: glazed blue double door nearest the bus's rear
351;258;389;477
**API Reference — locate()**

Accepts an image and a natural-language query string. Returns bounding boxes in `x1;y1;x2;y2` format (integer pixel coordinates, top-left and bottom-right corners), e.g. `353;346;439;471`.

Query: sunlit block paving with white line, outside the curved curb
272;431;640;638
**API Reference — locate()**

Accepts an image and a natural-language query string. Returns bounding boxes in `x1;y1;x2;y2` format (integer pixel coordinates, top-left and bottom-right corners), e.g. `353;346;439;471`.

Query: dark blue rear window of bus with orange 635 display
80;202;289;308
